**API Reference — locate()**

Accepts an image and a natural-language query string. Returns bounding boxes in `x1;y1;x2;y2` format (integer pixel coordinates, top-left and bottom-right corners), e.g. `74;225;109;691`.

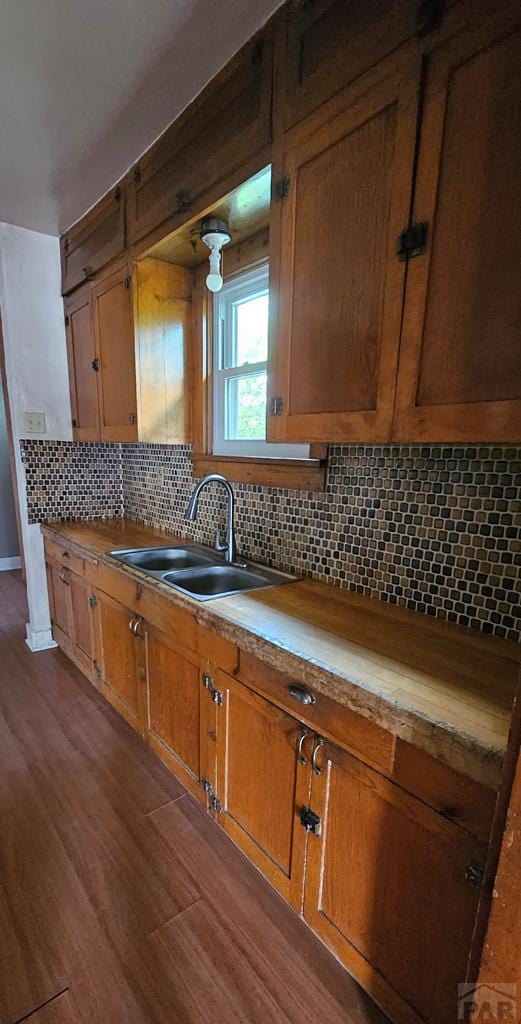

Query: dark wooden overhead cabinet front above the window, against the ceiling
128;25;272;244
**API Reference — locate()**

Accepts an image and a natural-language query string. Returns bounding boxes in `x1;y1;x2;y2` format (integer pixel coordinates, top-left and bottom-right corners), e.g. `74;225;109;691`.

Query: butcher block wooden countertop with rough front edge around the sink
43;519;521;788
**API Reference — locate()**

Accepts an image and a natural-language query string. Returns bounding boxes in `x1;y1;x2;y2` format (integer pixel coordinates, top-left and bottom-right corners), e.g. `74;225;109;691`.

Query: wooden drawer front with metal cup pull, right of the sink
238;651;395;773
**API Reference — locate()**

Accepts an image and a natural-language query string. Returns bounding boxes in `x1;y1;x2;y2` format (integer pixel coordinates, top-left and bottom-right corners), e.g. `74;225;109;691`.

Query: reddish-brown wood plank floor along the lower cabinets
0;572;386;1024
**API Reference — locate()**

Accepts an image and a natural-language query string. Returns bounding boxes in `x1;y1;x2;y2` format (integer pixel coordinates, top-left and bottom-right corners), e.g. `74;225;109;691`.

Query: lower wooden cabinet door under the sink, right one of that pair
146;626;201;788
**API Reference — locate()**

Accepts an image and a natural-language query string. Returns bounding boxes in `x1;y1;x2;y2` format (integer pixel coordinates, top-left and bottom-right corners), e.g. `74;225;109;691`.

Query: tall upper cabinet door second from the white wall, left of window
92;267;137;441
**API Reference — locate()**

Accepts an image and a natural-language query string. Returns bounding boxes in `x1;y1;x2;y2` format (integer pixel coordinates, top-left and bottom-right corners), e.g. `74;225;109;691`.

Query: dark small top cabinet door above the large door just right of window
285;0;418;127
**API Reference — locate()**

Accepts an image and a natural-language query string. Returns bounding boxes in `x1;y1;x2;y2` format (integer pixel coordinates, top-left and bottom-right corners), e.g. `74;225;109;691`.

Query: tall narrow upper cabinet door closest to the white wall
64;287;99;441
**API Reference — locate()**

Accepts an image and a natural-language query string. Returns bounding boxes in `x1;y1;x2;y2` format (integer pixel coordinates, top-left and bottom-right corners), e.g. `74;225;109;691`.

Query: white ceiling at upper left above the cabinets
0;0;280;234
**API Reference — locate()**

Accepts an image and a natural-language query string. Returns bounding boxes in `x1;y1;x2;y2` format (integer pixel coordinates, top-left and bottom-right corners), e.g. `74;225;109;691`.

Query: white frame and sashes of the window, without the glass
213;262;309;459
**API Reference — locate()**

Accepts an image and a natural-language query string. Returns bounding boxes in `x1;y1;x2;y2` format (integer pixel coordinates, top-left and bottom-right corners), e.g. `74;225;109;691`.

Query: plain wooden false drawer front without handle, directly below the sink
93;565;197;650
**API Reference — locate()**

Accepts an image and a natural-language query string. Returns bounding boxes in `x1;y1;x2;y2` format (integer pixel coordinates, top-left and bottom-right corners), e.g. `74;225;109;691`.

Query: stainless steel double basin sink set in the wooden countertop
110;544;296;601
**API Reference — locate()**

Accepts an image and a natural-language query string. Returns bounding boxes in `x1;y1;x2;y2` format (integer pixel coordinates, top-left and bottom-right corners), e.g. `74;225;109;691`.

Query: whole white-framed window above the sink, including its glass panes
213;263;309;459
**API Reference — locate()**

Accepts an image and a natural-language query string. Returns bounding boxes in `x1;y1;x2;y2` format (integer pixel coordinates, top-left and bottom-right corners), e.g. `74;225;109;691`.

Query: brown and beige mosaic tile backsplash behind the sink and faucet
24;441;521;640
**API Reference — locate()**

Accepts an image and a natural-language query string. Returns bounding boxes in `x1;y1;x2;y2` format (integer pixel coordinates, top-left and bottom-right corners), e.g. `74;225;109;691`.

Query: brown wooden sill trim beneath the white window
192;445;328;492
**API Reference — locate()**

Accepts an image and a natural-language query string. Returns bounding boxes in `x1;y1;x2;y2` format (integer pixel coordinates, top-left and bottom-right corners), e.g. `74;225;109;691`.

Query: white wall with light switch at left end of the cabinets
0;222;72;650
